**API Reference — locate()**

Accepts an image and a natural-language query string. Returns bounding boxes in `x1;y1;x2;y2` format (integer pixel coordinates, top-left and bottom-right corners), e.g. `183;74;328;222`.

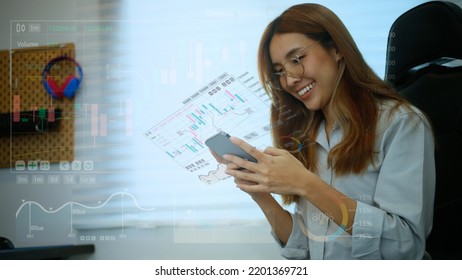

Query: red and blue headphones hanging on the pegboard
42;56;83;99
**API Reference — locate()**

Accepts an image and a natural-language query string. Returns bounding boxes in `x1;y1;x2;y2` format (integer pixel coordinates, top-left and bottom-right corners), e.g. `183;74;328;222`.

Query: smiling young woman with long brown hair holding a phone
215;4;435;259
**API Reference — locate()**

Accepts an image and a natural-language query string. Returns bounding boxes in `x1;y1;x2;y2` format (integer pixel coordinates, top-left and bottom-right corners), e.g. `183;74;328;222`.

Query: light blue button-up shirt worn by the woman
273;103;435;259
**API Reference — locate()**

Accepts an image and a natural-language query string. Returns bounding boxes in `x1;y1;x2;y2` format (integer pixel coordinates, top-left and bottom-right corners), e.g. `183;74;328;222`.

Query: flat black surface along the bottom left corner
0;244;95;260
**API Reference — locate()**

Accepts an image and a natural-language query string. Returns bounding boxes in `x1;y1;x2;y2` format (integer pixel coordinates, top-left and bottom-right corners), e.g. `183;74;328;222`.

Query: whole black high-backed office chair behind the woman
385;1;462;259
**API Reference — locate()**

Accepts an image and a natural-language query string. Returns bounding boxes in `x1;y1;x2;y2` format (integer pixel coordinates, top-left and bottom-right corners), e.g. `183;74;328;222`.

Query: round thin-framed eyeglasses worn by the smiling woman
266;42;316;90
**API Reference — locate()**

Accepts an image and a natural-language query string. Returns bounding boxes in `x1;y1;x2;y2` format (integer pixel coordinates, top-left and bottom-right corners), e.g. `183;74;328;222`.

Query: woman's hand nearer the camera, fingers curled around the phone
224;137;311;195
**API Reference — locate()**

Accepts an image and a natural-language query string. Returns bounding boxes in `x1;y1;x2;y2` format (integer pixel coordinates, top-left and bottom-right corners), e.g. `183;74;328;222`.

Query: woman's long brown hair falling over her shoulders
258;4;408;204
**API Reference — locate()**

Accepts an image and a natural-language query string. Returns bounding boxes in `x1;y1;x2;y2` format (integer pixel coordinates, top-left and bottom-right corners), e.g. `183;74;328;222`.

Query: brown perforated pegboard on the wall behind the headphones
0;43;77;168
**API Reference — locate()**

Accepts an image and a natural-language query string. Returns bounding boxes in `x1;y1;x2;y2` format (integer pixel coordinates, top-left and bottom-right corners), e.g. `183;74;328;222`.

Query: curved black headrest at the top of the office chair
385;1;462;86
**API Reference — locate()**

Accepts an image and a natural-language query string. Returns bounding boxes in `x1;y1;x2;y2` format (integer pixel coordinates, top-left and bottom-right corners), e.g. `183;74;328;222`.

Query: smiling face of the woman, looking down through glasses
269;33;342;115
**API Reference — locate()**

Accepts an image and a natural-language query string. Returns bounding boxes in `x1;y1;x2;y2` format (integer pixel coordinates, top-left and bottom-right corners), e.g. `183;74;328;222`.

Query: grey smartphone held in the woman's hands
205;131;257;162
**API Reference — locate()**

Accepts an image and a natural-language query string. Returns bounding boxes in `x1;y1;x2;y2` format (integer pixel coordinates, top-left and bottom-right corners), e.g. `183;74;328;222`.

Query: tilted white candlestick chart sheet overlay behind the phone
144;72;271;184
